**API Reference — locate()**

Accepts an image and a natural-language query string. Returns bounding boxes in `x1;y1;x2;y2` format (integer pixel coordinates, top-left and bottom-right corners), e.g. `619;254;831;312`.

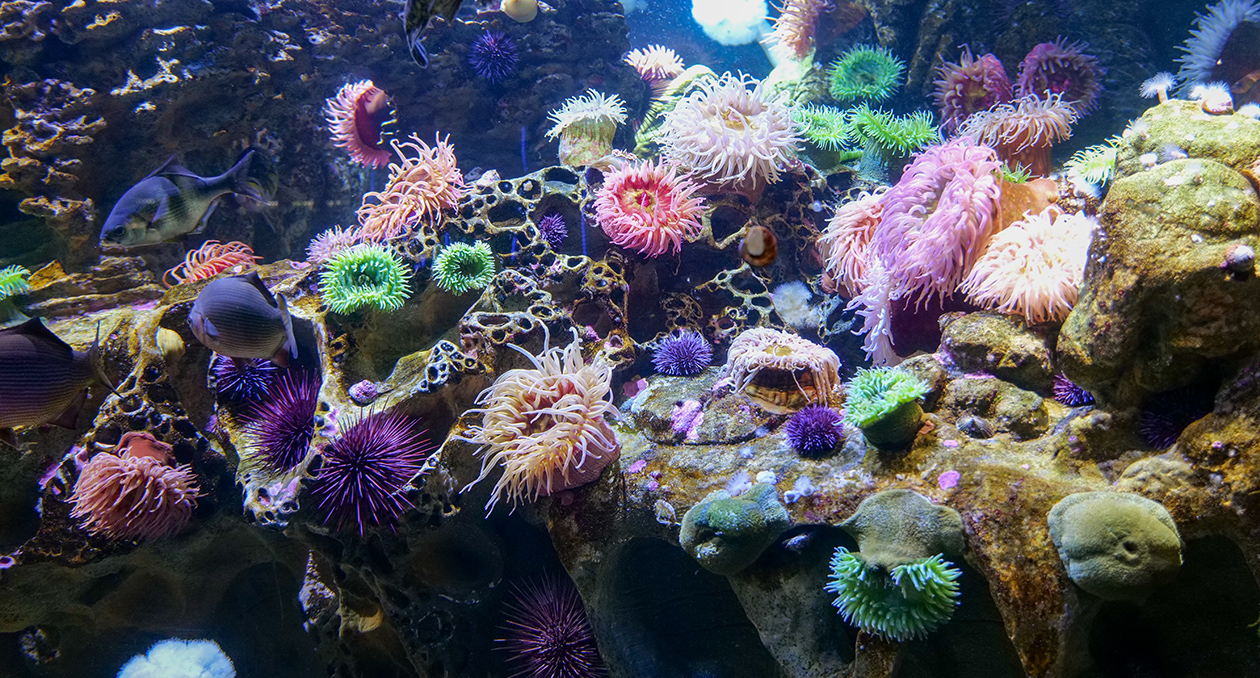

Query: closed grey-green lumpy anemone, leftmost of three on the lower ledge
678;483;791;575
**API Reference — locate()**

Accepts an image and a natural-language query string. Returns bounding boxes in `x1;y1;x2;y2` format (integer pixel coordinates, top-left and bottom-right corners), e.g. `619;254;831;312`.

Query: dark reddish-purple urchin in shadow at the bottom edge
499;578;606;678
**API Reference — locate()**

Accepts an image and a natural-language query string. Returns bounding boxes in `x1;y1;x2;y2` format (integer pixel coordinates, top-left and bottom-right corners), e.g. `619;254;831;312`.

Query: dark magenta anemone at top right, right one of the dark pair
1016;38;1104;116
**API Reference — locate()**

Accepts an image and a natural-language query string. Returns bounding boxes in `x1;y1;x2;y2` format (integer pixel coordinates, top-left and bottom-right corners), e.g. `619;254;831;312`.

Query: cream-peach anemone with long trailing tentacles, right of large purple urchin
459;333;620;513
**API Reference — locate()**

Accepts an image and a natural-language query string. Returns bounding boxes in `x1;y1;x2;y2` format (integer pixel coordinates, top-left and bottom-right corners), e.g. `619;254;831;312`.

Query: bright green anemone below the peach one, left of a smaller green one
319;244;411;314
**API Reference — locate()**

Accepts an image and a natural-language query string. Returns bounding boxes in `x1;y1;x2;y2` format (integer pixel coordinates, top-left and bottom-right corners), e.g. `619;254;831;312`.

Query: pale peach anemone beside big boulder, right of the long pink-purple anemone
961;205;1097;325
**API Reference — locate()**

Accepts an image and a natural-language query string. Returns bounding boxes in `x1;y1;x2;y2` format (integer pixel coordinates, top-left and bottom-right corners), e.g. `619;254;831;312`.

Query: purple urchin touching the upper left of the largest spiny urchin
244;372;320;473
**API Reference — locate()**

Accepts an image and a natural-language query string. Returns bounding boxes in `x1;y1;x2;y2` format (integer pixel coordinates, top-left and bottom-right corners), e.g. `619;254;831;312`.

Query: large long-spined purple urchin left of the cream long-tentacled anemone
311;412;432;537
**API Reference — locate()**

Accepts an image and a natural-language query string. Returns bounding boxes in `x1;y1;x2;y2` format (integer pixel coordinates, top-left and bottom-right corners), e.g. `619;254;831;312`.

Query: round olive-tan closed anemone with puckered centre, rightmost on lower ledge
1047;491;1182;600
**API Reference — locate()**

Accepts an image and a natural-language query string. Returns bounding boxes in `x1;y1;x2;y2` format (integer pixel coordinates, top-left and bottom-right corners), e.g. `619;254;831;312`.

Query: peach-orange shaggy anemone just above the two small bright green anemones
357;135;464;242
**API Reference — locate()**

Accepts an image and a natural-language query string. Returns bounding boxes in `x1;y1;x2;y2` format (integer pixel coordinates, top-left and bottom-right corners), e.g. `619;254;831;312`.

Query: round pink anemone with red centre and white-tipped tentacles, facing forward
595;160;704;257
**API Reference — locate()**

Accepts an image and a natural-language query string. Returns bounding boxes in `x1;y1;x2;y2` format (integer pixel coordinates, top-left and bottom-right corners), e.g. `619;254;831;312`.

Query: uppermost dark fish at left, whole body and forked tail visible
101;151;266;247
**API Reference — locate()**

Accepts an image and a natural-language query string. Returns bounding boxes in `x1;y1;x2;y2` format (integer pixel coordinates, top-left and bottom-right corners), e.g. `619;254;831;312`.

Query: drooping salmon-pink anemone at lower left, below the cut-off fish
71;432;199;539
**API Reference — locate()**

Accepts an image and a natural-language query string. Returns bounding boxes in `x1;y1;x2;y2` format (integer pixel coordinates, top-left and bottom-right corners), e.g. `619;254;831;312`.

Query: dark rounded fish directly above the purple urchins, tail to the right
188;271;297;367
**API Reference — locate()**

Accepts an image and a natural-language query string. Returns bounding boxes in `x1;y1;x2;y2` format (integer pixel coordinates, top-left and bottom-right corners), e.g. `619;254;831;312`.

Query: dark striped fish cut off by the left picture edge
0;318;113;447
